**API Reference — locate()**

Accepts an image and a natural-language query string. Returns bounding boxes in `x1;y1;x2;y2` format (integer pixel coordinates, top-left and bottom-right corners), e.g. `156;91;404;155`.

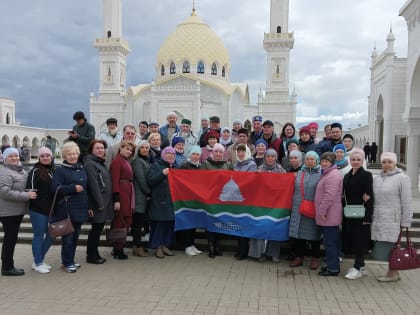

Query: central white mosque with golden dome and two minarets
90;0;296;133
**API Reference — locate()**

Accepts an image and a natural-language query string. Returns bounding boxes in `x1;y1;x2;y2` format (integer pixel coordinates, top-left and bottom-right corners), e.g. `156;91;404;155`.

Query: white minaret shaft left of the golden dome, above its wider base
94;0;130;93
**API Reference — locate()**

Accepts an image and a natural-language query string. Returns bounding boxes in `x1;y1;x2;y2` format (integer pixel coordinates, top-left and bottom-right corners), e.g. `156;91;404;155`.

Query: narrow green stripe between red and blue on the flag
174;200;290;219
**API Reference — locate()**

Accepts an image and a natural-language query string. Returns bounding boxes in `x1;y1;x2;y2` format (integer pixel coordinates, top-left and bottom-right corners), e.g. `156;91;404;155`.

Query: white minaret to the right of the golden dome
258;0;296;130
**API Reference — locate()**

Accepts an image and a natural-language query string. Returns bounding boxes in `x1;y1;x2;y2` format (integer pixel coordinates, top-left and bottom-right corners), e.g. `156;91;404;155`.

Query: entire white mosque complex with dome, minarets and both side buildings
0;0;420;193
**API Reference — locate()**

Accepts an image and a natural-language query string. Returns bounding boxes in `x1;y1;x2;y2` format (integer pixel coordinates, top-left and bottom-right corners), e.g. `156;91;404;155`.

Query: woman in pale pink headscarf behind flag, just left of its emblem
201;143;233;258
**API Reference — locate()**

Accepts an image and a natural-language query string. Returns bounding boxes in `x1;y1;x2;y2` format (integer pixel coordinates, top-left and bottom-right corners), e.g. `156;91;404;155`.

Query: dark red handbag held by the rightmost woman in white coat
389;228;420;270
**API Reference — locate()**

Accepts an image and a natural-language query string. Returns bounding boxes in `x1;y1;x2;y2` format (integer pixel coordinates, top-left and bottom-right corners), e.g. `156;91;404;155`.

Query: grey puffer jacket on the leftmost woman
0;165;29;217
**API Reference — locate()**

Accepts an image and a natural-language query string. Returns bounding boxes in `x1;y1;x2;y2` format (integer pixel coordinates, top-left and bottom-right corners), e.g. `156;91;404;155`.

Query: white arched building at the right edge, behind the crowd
369;0;420;192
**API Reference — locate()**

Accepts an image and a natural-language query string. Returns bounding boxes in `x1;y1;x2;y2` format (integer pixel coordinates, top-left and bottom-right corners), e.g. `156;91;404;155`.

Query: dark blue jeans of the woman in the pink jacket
321;226;340;272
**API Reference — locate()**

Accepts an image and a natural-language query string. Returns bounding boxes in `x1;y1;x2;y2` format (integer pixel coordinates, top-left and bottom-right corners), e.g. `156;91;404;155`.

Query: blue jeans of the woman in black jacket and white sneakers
29;210;54;266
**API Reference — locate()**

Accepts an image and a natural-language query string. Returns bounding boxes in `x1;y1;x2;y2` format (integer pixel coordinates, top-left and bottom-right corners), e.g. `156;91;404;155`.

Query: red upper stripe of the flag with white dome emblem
169;169;295;209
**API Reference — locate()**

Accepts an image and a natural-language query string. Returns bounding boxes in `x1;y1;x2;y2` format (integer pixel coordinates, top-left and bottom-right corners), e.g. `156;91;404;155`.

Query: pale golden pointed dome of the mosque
156;10;230;77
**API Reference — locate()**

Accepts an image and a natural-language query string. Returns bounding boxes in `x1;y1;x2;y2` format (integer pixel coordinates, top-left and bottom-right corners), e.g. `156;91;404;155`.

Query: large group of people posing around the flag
0;112;412;282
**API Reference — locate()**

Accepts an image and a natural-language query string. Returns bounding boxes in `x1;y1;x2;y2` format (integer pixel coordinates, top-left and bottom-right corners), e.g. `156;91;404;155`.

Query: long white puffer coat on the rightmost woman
371;168;413;243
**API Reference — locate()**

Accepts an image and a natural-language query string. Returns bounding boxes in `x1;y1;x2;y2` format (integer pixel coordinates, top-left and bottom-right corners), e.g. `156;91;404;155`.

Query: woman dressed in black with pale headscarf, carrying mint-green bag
342;149;373;280
